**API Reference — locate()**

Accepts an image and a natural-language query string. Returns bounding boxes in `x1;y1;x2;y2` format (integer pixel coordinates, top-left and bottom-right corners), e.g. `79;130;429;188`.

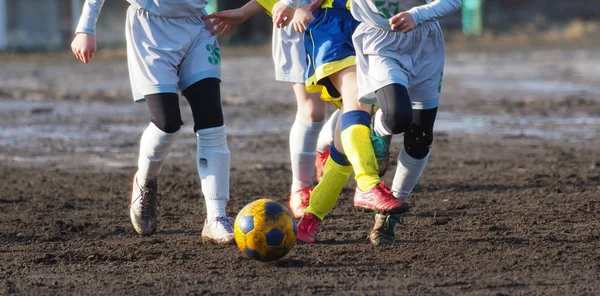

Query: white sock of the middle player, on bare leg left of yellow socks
290;115;325;192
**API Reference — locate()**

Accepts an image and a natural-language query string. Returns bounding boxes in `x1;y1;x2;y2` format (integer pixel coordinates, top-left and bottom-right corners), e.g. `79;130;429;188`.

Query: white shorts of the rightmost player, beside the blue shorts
352;22;445;109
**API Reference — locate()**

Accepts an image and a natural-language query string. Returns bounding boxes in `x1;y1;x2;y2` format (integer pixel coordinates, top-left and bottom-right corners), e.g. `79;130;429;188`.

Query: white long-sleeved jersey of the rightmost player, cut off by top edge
350;0;462;31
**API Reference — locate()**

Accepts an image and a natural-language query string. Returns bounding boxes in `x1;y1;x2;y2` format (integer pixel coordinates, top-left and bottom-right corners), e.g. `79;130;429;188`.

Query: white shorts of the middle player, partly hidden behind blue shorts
272;24;308;83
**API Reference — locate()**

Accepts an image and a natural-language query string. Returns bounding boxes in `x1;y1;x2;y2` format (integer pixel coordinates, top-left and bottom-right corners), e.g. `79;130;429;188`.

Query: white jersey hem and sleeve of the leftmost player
76;0;208;35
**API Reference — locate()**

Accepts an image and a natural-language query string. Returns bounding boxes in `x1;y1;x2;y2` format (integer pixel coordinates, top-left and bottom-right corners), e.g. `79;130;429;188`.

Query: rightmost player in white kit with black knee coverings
351;0;461;245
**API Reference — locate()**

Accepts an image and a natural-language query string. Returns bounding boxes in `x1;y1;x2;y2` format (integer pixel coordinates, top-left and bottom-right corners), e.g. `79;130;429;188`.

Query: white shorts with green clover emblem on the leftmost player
125;6;221;101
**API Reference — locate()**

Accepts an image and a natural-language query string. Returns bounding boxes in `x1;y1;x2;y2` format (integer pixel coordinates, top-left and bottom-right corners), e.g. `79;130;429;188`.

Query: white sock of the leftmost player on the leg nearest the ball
196;125;231;220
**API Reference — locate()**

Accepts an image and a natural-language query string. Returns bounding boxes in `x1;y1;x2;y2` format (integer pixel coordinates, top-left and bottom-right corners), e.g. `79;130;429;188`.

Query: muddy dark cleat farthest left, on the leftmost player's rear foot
129;177;158;235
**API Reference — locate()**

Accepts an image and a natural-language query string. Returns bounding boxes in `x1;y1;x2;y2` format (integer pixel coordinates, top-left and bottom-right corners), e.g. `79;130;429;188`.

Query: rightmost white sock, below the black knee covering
392;148;431;201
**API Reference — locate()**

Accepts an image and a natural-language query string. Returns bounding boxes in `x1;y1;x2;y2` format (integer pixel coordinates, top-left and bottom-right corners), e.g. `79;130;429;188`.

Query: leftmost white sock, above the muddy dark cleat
136;122;179;186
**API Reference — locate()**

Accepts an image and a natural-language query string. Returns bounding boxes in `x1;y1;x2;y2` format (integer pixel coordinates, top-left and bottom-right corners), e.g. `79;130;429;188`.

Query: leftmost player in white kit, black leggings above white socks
71;0;234;244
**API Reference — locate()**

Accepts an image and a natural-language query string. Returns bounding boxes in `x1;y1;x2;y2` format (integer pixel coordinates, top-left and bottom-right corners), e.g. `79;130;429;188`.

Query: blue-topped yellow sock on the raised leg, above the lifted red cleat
341;110;381;191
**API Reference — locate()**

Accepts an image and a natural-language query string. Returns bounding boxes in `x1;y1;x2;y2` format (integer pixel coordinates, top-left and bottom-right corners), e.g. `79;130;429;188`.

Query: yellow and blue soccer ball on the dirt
234;199;296;261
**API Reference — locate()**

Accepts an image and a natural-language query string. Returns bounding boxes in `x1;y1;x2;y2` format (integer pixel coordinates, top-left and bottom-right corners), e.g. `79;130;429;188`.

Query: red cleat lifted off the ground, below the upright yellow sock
354;181;408;214
